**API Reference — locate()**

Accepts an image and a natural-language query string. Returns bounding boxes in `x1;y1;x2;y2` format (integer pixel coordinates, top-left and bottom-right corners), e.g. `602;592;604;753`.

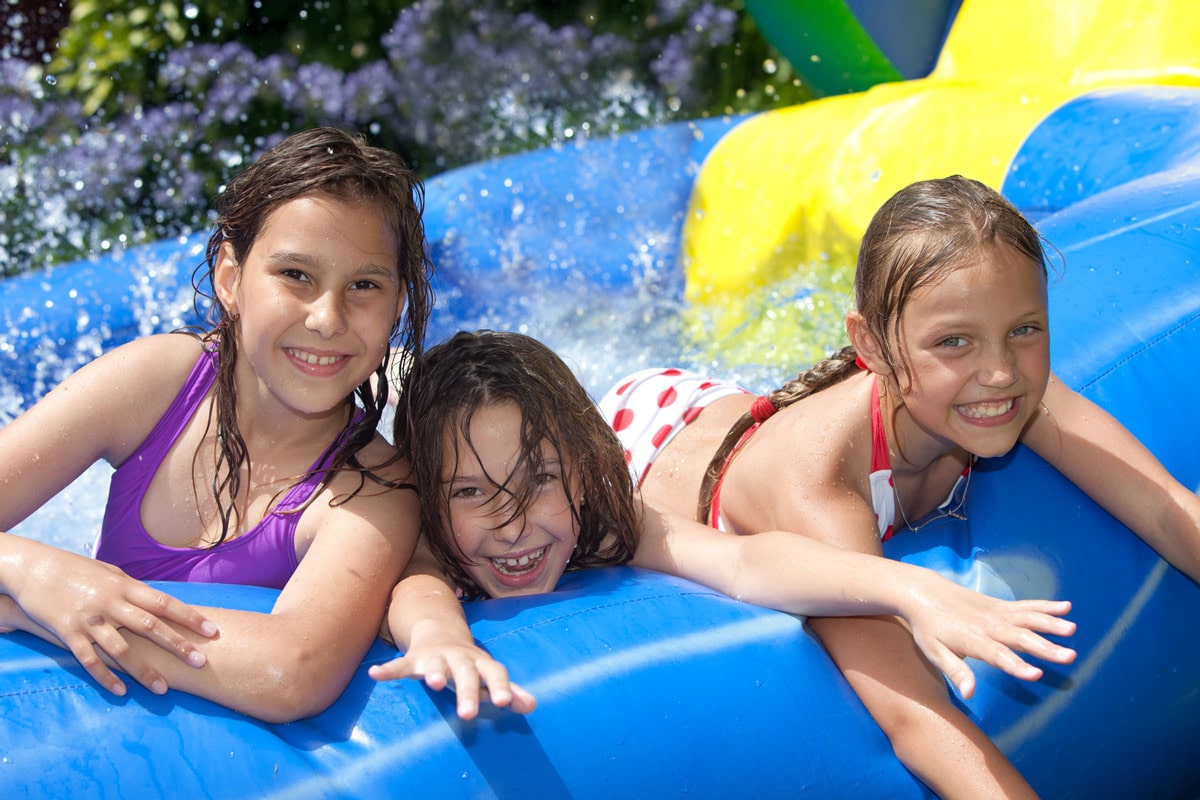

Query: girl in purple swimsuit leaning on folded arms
0;128;431;721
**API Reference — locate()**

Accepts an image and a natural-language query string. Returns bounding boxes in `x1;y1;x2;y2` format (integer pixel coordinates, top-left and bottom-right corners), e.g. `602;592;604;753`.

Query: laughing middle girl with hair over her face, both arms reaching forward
371;332;1074;716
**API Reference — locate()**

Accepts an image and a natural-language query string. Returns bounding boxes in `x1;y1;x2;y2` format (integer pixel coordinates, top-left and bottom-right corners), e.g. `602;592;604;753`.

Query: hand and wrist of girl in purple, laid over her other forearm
4;540;217;696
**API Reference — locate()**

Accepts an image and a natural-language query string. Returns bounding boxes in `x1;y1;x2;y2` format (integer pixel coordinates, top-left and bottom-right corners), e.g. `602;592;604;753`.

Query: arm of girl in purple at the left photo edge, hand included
0;335;215;693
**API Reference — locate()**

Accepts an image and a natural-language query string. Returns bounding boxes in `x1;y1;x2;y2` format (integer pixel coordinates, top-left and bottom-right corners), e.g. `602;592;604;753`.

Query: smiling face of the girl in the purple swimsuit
214;194;404;416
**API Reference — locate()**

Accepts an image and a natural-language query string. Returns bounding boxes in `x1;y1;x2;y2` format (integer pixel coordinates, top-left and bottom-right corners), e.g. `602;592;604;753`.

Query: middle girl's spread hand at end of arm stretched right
905;576;1075;699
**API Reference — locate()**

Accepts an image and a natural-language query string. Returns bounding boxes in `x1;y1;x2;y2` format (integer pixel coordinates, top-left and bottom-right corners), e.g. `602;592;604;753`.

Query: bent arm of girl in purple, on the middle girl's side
96;476;418;722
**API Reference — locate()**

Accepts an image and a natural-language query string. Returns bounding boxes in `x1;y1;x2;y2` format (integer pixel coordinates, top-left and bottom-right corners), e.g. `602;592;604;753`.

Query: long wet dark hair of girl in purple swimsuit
192;127;433;543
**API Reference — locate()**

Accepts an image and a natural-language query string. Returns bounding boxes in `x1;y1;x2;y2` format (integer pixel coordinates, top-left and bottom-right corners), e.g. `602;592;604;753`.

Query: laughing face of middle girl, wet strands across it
442;402;580;597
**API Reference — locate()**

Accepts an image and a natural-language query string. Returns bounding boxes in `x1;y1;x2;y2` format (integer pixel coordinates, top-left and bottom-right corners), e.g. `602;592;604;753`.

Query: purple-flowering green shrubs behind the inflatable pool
0;0;809;275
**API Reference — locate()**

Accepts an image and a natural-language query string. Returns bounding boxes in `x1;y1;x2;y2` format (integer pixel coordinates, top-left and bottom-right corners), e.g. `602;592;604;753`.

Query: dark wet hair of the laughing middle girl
395;331;642;597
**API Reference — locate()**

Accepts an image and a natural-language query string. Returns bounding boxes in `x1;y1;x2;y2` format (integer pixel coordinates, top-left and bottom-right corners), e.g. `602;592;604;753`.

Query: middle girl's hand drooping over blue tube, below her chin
368;643;538;720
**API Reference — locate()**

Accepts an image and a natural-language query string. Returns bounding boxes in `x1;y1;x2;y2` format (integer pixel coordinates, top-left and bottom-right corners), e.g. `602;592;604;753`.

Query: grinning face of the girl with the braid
896;245;1050;457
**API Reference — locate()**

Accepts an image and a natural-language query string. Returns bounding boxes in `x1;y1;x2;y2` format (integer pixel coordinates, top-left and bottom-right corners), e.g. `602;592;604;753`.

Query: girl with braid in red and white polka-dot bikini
601;176;1200;799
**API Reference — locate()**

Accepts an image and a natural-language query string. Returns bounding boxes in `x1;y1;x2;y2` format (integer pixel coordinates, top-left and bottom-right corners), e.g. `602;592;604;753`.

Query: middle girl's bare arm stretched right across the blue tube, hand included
634;507;1075;697
